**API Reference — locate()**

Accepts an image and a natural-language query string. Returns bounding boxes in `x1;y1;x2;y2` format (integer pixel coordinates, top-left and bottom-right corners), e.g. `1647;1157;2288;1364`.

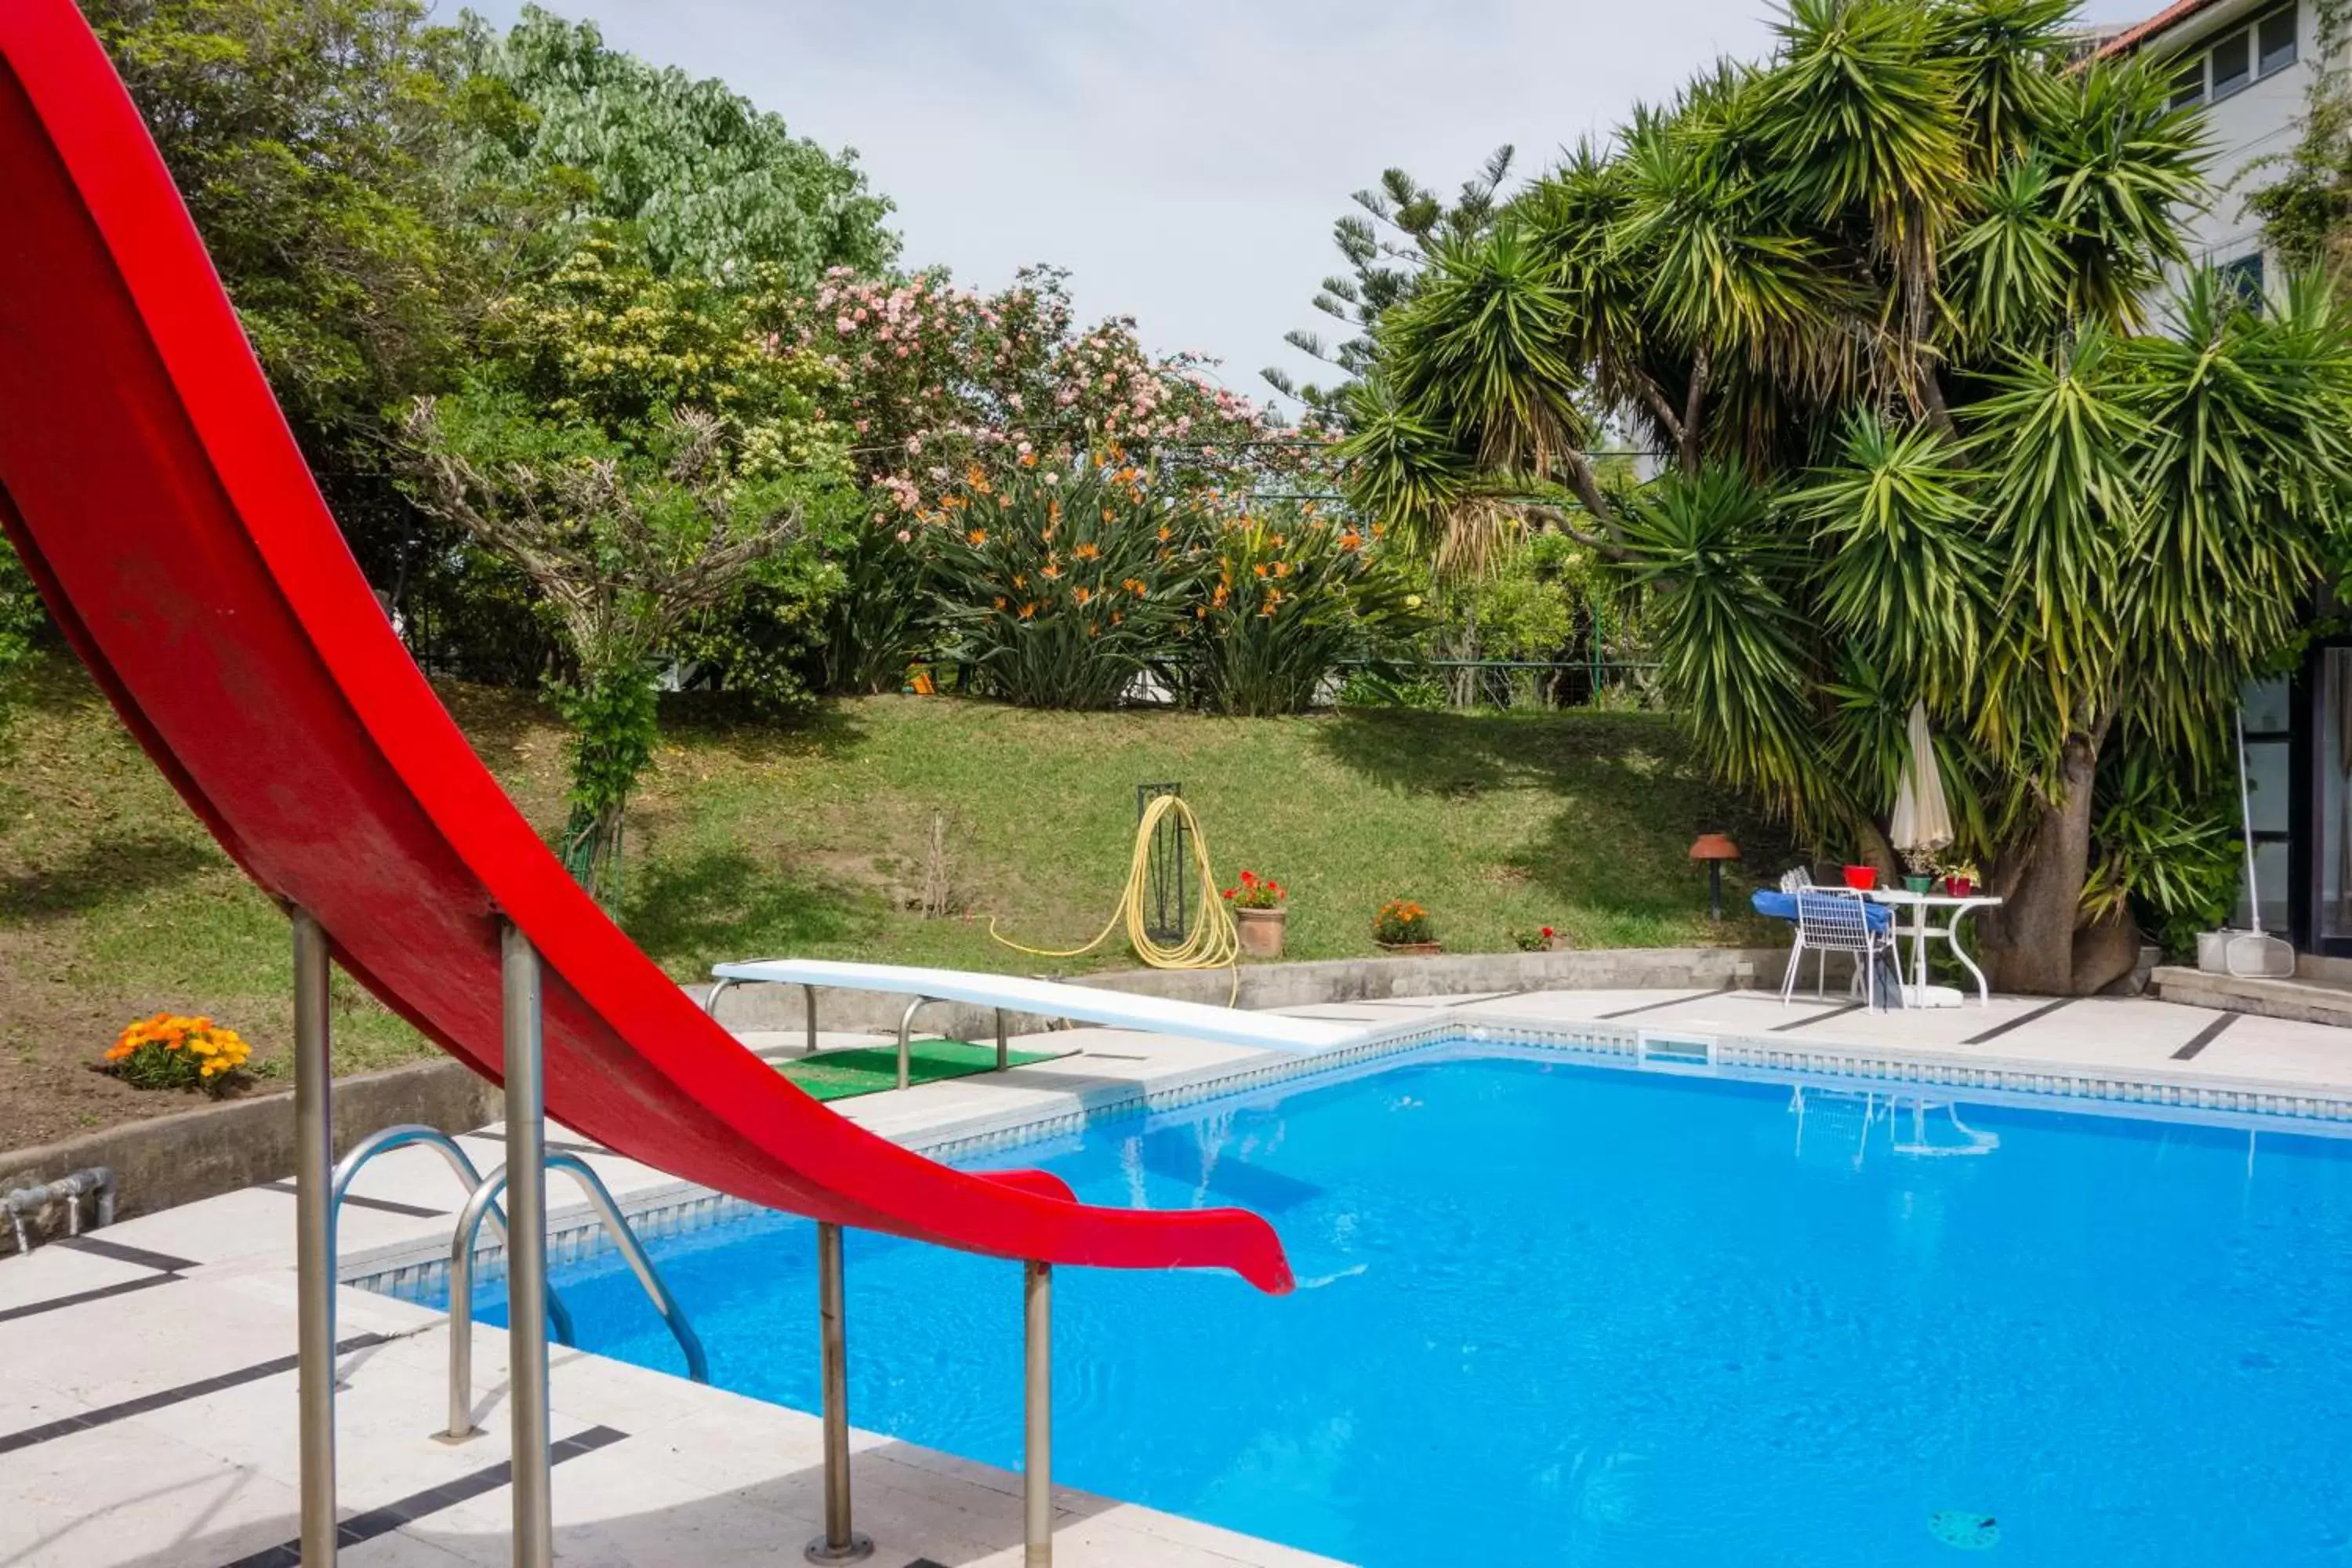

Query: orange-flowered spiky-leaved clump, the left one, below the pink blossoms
917;449;1202;708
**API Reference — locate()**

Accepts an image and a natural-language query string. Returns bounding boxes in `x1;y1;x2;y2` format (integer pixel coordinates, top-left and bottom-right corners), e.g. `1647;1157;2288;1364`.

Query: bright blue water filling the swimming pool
428;1046;2352;1568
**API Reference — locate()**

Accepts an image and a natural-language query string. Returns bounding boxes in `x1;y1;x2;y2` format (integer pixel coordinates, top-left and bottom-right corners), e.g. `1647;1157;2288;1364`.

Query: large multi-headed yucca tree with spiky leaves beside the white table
1343;0;2352;992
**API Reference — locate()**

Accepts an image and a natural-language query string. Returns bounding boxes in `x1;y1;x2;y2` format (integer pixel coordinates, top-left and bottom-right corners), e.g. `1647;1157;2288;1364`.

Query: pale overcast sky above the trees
463;0;2159;420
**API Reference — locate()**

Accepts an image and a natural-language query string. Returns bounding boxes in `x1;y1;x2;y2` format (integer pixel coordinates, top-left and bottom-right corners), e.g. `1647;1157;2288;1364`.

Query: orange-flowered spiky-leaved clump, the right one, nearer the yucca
1192;503;1421;717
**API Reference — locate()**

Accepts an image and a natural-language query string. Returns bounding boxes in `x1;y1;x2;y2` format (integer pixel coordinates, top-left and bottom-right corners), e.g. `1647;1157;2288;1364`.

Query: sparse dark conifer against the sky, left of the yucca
1258;146;1517;428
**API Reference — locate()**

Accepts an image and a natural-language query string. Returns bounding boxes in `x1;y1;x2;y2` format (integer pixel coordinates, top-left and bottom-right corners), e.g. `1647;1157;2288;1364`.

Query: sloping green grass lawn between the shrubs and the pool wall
0;659;1788;1147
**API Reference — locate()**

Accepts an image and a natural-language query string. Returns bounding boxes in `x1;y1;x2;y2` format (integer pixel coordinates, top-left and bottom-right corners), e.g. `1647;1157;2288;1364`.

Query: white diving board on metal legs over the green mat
703;959;1378;1088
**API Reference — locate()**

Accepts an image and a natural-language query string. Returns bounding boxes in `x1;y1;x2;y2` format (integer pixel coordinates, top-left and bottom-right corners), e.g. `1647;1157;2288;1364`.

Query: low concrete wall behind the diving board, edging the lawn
687;947;1788;1039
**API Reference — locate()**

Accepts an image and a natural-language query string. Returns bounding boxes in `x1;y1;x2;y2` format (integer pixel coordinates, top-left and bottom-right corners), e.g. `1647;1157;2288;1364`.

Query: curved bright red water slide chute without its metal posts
0;0;1291;1290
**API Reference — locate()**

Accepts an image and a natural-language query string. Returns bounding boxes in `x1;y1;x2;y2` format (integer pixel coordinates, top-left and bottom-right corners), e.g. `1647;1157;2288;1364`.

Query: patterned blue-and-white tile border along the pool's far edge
341;1008;2352;1300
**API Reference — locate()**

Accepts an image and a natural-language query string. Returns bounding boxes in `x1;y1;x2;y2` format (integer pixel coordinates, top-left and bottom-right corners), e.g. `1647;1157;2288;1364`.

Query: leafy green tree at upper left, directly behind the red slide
82;0;480;583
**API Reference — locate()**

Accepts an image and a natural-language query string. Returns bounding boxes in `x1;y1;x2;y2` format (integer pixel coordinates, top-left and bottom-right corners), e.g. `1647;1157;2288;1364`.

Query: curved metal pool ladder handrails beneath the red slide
327;1123;710;1443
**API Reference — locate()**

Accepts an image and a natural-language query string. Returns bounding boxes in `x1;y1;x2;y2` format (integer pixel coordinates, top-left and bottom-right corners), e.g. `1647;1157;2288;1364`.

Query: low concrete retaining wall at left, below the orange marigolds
0;1060;503;1232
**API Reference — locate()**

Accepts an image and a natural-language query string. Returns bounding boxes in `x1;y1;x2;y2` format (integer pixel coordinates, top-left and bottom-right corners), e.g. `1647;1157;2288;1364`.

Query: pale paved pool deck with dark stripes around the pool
0;989;2352;1568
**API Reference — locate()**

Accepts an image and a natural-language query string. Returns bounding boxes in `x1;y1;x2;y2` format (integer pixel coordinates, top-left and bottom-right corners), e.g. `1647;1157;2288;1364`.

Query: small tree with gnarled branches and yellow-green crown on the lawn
402;230;849;898
